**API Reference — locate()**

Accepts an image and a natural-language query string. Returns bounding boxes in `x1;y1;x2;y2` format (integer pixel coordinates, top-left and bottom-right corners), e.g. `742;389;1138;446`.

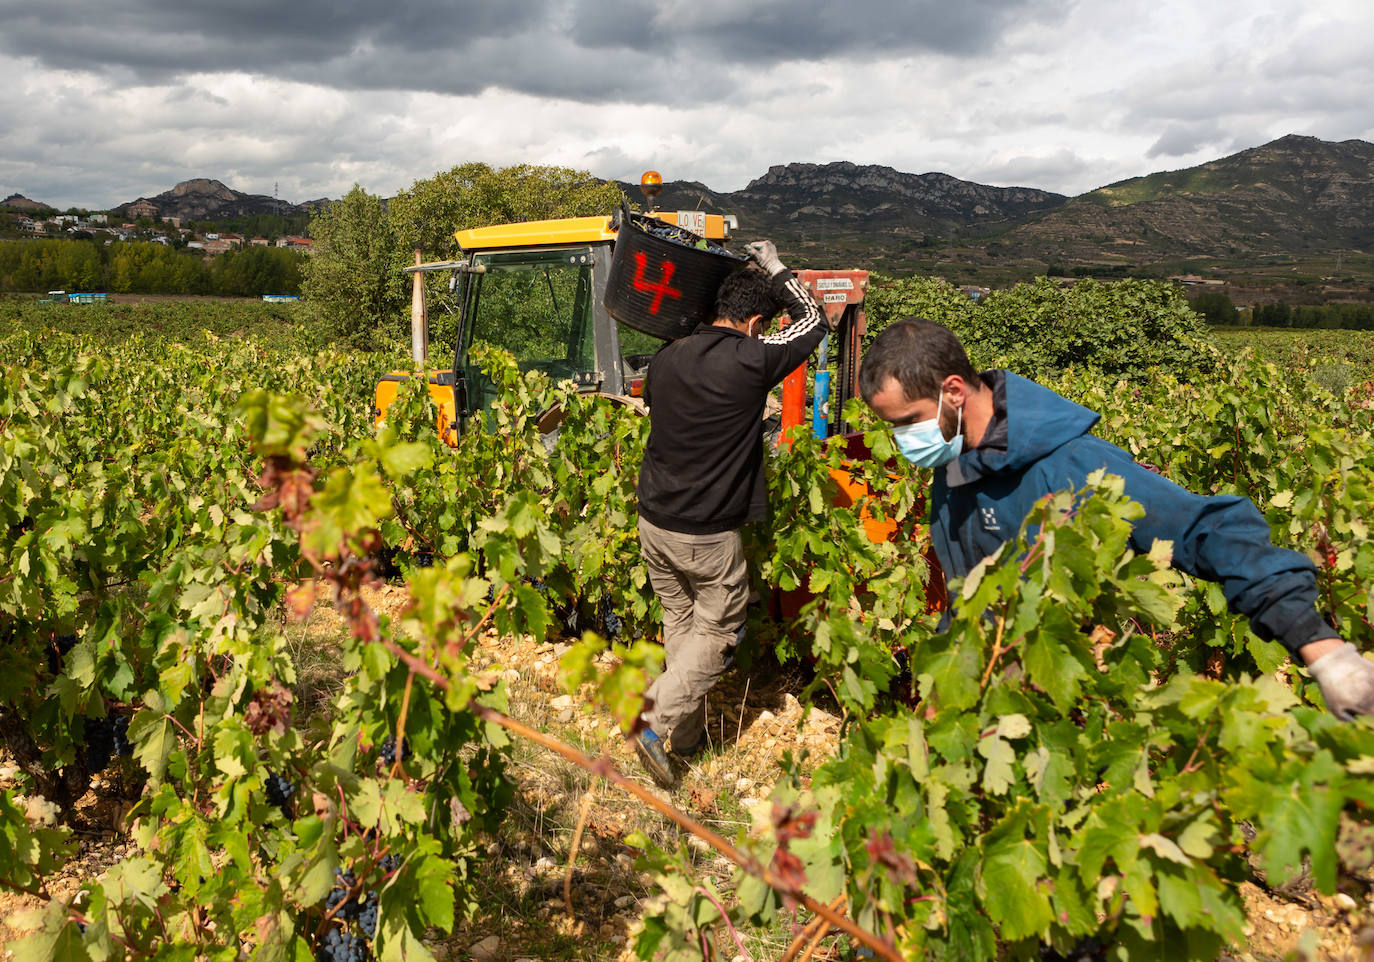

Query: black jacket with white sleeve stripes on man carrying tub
639;271;826;535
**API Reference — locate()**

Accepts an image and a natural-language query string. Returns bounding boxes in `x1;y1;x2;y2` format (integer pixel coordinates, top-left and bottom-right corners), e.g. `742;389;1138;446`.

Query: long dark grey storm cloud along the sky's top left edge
0;0;1072;103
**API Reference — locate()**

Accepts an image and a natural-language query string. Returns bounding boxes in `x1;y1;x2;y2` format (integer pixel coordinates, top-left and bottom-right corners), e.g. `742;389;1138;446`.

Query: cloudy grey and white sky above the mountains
0;0;1374;209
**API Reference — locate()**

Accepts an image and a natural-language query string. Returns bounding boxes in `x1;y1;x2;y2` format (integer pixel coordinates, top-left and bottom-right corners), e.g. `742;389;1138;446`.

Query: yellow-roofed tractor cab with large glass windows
375;212;734;444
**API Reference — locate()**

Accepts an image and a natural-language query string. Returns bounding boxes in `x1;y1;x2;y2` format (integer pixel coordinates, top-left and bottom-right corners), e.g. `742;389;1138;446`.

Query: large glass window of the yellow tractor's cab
462;249;596;412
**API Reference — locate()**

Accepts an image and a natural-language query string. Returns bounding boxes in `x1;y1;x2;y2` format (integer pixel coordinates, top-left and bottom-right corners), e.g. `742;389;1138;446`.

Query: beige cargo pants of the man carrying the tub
639;518;749;749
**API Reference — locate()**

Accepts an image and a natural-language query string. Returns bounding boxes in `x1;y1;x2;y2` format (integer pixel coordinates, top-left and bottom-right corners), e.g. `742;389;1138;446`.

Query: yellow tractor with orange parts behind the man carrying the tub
374;180;943;614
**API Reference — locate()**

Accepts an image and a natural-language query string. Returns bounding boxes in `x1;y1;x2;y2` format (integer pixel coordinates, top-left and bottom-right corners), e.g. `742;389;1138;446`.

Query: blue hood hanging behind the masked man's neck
945;371;1102;488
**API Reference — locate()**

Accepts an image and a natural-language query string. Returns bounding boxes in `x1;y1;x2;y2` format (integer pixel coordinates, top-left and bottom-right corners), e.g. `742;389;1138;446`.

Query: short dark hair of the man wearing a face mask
859;317;978;403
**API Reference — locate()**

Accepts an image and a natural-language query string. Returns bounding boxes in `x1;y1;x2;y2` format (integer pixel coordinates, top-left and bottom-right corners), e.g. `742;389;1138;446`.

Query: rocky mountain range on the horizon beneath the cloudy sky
10;135;1374;287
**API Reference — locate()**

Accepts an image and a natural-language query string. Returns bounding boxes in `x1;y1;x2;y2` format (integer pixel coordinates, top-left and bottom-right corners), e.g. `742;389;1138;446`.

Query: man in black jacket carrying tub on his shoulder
635;241;827;787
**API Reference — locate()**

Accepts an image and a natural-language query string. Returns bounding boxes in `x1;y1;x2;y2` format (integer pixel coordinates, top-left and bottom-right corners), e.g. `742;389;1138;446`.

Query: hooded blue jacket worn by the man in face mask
930;371;1336;653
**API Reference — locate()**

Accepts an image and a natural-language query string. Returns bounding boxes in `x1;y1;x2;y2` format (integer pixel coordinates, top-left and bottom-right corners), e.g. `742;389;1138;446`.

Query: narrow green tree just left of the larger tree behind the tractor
301;184;392;346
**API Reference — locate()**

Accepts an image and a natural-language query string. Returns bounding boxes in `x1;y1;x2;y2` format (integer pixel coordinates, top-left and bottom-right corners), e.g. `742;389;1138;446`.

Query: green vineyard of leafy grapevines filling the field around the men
0;292;1374;962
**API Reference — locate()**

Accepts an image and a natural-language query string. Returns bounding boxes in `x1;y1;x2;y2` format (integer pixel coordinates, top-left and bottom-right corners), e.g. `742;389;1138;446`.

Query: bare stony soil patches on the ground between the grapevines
0;585;1374;962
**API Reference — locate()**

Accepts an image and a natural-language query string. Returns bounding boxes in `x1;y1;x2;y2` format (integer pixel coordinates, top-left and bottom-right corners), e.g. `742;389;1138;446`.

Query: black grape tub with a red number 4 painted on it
605;206;747;341
